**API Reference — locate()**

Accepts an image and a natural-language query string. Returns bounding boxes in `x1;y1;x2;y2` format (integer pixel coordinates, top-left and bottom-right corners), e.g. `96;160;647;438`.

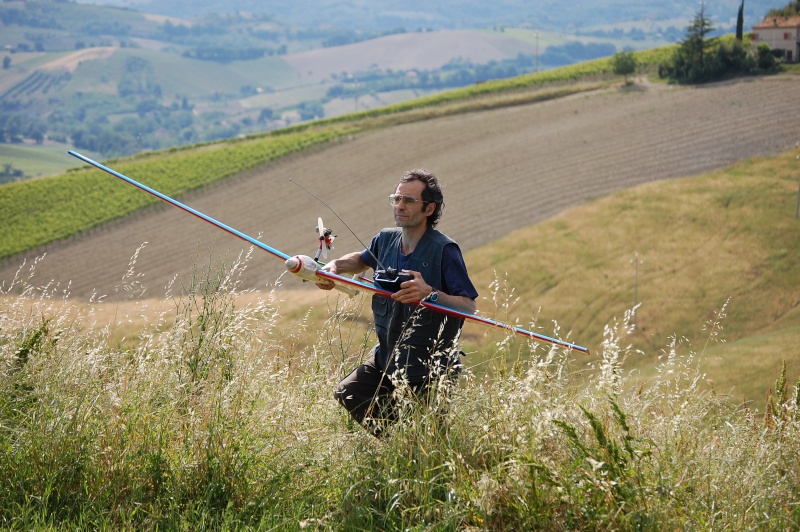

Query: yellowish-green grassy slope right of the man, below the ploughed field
468;150;800;403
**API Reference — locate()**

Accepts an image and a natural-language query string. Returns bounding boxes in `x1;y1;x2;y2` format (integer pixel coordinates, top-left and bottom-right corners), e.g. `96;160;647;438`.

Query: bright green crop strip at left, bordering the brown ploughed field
0;129;342;258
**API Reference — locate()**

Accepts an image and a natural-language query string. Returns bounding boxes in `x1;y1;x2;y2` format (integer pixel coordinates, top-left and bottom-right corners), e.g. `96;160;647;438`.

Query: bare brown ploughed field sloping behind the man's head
0;76;800;298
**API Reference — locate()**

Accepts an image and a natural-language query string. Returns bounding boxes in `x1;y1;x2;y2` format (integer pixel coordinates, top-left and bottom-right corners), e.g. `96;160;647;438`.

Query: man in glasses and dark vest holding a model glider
318;170;478;436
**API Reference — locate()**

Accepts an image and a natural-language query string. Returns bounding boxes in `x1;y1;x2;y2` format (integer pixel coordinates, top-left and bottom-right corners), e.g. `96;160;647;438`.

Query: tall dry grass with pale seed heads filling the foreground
0;251;800;530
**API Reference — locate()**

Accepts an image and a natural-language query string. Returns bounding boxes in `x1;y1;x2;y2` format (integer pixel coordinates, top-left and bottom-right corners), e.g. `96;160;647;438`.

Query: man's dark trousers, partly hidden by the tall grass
334;357;455;436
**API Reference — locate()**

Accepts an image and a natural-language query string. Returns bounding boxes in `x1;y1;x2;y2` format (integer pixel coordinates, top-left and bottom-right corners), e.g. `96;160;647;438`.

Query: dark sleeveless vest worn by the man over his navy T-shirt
372;228;464;383
